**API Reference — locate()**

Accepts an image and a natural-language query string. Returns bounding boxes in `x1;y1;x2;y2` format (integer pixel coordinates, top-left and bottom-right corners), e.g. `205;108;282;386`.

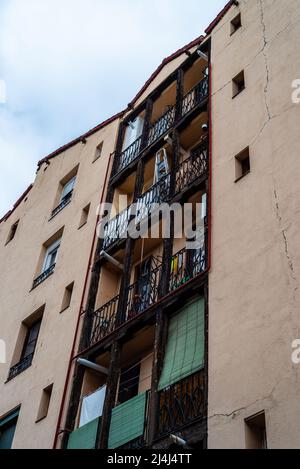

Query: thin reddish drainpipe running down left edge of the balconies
53;149;113;449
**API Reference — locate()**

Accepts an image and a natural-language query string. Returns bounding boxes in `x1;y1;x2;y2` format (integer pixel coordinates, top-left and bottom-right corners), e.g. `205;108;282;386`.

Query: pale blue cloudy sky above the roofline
0;0;226;217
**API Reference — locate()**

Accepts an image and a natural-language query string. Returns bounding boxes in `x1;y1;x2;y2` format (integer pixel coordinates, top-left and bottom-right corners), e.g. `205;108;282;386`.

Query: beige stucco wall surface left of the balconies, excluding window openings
0;117;118;448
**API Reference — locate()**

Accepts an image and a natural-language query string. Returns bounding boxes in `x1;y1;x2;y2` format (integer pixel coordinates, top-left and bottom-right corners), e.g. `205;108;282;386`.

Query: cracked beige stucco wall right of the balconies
208;0;300;448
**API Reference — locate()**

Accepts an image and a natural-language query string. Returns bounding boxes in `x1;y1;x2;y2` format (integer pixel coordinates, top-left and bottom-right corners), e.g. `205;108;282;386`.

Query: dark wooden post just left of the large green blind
147;309;168;447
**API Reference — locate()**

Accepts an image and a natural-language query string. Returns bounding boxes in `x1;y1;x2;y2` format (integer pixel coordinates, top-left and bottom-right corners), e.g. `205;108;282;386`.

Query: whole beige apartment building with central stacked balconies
0;0;300;449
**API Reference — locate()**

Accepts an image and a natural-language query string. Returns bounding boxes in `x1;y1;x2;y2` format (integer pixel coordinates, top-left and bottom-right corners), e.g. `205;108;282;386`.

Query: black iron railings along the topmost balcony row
113;77;208;175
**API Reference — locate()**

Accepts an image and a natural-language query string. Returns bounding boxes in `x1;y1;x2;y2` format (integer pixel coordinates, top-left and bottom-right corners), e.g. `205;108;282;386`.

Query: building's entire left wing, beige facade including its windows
0;116;119;448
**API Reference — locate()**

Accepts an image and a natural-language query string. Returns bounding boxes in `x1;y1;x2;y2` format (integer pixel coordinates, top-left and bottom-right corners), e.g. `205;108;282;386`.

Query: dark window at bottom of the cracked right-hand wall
245;412;268;449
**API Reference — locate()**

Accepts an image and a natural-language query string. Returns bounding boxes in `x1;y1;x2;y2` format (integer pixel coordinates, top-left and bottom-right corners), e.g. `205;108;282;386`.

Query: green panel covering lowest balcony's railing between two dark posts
108;393;146;449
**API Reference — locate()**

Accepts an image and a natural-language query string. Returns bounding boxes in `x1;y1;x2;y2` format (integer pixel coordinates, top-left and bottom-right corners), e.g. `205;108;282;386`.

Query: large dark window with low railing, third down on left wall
8;305;45;380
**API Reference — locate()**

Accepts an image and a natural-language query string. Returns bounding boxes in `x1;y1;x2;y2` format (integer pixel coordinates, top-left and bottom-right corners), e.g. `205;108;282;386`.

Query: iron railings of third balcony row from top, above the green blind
84;246;206;347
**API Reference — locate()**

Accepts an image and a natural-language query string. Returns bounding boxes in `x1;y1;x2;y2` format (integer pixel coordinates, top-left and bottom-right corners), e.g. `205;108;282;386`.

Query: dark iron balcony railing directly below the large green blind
157;369;205;438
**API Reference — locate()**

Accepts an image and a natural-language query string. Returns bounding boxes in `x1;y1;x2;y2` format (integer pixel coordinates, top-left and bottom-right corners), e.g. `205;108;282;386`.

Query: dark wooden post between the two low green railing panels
96;341;121;449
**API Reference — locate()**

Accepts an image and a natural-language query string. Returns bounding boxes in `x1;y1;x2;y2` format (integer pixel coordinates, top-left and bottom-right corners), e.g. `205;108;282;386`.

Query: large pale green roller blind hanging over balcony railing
158;298;205;390
